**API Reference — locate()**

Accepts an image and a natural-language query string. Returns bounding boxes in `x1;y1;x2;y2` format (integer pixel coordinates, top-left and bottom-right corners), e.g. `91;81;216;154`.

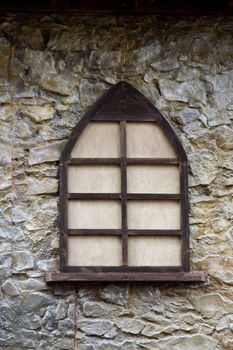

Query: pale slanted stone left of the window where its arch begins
28;141;65;165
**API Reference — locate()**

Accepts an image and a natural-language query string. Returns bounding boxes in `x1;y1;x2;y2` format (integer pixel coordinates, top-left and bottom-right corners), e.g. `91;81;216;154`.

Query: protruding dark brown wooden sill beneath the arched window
46;272;206;282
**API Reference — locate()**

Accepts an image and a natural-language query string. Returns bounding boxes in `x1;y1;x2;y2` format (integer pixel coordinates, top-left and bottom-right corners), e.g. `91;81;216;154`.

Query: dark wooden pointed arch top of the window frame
61;81;187;162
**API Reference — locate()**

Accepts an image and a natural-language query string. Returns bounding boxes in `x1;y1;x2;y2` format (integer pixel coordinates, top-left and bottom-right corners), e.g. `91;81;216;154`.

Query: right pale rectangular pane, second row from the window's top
127;165;180;193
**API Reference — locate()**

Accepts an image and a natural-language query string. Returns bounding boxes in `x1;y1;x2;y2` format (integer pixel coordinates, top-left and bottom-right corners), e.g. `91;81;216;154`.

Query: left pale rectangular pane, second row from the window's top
68;165;121;193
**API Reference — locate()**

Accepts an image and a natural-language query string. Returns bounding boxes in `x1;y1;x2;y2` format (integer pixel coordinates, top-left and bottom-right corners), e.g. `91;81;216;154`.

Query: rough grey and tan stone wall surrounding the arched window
0;14;233;350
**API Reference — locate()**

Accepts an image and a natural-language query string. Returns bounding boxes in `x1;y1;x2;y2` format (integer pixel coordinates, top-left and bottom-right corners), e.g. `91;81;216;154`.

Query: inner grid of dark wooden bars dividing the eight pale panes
66;119;182;270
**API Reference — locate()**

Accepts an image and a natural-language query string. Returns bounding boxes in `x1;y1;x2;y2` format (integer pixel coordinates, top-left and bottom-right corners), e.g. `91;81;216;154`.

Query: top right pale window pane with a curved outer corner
126;122;176;158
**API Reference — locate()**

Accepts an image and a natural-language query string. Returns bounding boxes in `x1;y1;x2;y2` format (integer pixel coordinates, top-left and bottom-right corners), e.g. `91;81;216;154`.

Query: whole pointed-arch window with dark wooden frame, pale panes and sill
47;82;203;281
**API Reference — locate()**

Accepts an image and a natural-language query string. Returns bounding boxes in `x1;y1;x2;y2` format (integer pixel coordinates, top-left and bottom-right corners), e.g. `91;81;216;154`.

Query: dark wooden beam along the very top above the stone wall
0;0;233;18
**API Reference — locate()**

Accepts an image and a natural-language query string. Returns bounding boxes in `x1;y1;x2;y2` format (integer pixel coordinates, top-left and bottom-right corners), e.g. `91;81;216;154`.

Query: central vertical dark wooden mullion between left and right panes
120;121;128;266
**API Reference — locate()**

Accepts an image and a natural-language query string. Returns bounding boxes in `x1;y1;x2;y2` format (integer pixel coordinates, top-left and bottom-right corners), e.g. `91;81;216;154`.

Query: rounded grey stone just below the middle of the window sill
101;285;129;305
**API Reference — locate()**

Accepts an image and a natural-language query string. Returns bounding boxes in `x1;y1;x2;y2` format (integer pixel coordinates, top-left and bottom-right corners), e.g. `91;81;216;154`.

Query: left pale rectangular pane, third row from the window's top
68;200;121;229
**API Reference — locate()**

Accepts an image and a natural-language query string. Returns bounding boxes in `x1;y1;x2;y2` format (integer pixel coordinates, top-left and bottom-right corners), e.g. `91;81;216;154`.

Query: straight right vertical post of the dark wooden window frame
180;162;190;272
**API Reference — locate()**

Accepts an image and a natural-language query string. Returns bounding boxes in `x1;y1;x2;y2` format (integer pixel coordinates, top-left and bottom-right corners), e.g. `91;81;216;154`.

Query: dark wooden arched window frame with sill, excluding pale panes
47;82;204;282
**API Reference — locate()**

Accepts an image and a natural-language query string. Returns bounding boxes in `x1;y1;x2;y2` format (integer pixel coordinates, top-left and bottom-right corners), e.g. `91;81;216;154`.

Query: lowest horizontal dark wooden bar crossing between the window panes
68;229;181;236
